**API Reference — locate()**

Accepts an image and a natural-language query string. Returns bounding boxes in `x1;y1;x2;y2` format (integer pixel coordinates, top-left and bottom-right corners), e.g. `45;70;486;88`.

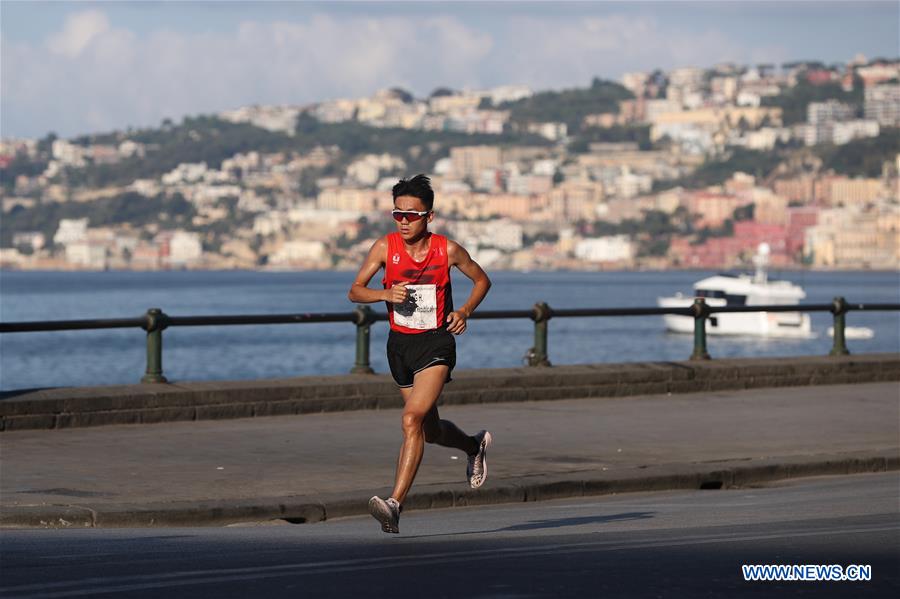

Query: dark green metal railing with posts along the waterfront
0;297;900;383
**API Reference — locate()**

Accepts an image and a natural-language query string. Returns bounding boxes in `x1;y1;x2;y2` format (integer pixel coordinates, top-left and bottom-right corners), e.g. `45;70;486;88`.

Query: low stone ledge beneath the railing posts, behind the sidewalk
0;354;900;432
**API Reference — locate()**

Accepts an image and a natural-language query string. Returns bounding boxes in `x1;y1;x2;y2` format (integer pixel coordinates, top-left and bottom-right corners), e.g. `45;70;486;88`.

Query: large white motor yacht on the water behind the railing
656;243;815;339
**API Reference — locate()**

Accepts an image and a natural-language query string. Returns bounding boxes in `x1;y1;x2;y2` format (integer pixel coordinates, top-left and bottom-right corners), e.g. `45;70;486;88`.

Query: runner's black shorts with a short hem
388;329;456;387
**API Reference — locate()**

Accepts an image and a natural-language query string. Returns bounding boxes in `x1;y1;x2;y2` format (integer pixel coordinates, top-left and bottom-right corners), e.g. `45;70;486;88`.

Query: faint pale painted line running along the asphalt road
4;523;900;599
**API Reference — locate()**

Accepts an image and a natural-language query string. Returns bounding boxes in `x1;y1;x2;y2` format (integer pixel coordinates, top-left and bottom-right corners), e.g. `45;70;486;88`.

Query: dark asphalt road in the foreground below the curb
0;472;900;599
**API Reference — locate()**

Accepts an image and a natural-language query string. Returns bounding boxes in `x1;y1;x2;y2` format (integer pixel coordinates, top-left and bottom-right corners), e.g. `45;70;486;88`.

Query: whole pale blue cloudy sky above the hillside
0;0;900;138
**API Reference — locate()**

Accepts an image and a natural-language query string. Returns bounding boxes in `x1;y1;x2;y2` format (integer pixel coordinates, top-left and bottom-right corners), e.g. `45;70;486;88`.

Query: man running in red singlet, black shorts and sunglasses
347;175;491;533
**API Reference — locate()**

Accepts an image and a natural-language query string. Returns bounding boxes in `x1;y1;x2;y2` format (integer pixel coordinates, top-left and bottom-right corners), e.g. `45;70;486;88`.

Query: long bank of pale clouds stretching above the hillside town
0;10;780;136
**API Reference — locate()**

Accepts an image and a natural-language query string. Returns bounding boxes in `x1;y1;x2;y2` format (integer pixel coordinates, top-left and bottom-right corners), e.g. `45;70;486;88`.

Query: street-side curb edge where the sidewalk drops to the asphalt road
0;448;900;528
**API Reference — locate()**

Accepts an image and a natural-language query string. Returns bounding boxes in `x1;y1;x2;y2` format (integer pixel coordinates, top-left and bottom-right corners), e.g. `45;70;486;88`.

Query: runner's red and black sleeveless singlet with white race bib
381;233;453;334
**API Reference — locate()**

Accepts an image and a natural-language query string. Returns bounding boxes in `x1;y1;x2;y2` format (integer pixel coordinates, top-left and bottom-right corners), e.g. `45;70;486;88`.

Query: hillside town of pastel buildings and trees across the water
0;57;900;270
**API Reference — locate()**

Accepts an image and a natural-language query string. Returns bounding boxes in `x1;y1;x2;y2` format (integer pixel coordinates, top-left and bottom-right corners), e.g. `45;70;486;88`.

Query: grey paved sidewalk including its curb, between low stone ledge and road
0;382;900;527
